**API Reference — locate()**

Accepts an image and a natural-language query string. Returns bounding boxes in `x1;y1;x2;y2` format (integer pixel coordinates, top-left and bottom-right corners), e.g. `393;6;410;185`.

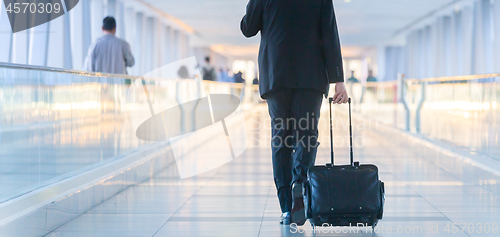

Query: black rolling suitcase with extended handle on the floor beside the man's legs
304;98;385;228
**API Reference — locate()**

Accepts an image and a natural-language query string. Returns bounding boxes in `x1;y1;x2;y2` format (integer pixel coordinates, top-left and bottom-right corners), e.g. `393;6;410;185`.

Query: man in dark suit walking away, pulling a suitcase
241;0;348;225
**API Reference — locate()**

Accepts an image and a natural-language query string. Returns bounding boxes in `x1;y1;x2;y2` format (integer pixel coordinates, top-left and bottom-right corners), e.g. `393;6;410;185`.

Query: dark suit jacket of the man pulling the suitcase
241;0;344;98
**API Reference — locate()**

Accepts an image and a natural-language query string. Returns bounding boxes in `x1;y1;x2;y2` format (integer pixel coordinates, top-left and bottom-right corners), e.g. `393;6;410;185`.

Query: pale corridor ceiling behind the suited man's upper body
143;0;457;57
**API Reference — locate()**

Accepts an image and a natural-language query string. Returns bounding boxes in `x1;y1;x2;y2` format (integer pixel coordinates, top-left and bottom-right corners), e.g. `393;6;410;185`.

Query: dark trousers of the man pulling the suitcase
266;88;323;213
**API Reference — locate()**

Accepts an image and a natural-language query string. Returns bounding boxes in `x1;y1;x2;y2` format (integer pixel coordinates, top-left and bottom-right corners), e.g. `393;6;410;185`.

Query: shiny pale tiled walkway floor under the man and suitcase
48;108;500;237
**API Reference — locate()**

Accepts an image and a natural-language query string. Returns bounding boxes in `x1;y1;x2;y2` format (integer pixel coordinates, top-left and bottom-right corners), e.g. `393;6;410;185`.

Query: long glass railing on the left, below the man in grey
0;64;259;203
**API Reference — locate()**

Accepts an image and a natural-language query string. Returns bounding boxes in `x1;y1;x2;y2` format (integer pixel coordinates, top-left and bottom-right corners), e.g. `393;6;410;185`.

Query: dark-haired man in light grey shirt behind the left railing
83;16;135;74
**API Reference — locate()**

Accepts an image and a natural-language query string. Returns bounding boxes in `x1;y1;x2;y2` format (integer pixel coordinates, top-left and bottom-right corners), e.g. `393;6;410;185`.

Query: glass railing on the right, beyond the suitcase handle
347;74;500;160
